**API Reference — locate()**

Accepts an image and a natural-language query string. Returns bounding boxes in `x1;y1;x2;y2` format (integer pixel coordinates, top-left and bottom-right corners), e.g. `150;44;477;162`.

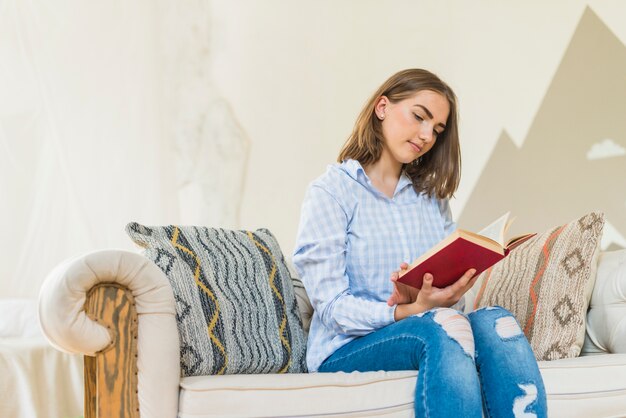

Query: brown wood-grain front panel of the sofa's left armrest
85;283;139;418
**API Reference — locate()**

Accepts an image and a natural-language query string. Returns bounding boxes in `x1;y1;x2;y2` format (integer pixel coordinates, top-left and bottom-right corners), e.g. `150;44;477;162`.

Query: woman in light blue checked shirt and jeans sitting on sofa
294;69;546;417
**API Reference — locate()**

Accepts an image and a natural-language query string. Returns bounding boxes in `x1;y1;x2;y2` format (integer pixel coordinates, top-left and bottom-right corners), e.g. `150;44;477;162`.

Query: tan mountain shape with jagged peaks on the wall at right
459;8;626;248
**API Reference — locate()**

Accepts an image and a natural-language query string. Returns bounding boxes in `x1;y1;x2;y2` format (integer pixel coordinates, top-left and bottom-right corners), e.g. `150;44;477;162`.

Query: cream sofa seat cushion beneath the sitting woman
179;354;626;418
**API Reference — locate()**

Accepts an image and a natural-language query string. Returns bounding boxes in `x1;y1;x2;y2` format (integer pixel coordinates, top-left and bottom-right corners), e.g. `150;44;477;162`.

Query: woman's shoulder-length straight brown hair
337;69;461;199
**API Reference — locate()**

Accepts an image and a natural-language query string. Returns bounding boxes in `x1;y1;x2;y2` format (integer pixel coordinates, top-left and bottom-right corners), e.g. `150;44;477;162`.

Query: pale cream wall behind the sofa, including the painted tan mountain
0;0;626;298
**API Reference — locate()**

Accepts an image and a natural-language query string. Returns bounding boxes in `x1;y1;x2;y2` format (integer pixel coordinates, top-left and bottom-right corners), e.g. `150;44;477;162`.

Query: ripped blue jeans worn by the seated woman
319;307;547;418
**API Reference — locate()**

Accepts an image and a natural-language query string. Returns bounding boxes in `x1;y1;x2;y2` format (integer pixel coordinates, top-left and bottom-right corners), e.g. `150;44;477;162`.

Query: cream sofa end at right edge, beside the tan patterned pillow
583;250;626;354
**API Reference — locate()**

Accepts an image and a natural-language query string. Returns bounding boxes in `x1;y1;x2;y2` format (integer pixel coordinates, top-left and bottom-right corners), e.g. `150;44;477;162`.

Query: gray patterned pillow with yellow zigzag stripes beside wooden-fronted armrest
126;222;306;377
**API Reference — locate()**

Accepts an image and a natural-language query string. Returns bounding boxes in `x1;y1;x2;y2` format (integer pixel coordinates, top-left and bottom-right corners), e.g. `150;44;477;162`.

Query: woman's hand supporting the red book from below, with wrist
394;269;478;321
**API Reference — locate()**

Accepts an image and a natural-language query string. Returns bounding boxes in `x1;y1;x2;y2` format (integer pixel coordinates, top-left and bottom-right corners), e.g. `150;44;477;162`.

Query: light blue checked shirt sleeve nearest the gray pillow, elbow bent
293;185;395;335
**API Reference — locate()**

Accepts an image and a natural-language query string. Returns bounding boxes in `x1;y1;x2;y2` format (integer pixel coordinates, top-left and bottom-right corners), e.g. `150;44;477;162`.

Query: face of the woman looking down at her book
375;90;450;164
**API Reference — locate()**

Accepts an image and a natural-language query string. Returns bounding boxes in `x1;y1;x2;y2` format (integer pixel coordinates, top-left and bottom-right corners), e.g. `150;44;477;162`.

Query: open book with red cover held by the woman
398;212;536;289
